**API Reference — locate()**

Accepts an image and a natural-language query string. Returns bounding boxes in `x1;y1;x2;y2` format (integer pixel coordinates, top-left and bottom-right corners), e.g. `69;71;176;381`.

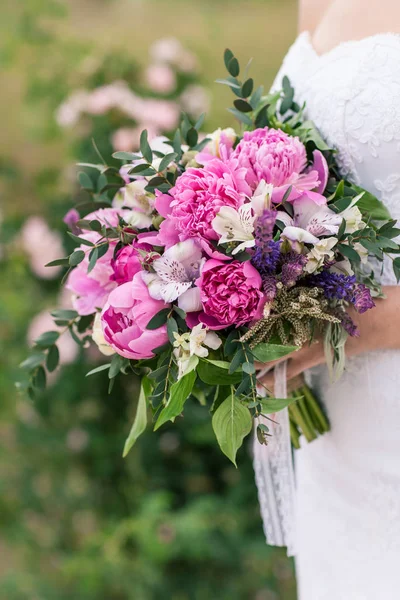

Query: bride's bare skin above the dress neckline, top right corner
312;0;400;55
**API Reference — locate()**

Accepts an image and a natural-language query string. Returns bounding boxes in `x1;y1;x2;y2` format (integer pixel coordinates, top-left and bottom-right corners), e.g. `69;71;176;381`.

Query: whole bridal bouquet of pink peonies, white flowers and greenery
23;50;400;464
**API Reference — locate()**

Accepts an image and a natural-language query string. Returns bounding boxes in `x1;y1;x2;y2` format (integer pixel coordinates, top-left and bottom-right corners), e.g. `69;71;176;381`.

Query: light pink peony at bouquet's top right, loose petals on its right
232;127;327;202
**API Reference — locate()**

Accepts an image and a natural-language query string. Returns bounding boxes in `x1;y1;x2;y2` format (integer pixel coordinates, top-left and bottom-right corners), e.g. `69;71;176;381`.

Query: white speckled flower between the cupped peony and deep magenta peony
142;240;204;302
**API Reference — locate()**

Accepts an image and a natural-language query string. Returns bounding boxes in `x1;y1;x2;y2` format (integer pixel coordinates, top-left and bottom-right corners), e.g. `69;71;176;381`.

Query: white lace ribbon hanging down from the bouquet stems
253;361;295;556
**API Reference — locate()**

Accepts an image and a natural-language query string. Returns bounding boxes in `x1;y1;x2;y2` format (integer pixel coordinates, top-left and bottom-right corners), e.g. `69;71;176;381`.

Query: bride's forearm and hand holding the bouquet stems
258;286;400;390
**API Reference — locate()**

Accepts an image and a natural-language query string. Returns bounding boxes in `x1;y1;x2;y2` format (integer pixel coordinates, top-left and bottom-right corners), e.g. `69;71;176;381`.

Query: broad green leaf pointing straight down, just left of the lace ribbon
212;394;252;467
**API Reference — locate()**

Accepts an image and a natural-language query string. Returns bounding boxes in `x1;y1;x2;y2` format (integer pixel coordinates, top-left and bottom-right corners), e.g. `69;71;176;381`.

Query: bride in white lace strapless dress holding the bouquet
263;0;400;600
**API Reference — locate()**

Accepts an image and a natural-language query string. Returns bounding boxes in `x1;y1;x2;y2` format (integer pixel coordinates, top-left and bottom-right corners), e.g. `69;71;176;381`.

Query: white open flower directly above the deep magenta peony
212;203;255;254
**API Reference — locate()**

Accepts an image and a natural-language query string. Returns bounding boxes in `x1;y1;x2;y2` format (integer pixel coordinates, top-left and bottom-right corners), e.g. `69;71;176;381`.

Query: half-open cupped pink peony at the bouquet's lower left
101;273;169;360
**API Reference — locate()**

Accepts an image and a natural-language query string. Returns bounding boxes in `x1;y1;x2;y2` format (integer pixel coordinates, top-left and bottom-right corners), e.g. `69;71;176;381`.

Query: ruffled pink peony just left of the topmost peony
156;158;251;250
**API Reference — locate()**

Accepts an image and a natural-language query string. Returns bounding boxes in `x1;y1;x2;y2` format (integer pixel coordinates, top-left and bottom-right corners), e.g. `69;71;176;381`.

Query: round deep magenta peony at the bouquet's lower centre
196;259;264;329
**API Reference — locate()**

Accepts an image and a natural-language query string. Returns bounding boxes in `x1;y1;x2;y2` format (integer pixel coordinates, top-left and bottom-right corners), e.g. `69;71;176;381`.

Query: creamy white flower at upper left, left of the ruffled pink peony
113;179;155;229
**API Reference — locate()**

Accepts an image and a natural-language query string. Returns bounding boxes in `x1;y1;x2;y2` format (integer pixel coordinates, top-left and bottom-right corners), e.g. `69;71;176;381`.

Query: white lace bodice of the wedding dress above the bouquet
274;32;400;285
